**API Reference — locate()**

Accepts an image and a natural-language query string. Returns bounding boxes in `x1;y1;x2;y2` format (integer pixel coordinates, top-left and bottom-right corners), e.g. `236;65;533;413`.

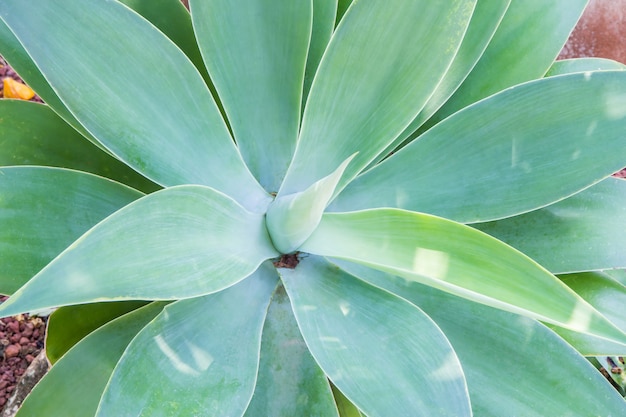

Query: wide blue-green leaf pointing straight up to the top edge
190;0;313;192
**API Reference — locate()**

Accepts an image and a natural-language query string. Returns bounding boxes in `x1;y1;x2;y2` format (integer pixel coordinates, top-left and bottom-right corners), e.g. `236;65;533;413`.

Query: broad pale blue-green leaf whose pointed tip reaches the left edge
0;185;278;316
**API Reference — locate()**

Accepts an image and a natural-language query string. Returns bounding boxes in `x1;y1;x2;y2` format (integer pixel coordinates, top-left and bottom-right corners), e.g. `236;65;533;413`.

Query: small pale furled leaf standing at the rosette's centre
266;155;355;253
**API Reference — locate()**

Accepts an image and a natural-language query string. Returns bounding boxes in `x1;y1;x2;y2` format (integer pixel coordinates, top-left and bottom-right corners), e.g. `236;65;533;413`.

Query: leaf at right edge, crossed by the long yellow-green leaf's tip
550;272;626;356
